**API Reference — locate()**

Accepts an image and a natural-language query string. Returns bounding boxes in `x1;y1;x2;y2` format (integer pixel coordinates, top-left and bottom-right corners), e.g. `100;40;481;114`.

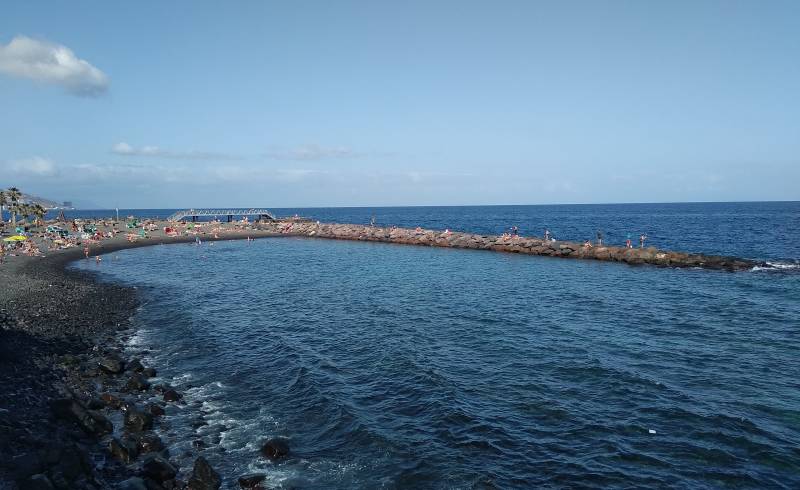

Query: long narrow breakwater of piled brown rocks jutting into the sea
272;221;760;271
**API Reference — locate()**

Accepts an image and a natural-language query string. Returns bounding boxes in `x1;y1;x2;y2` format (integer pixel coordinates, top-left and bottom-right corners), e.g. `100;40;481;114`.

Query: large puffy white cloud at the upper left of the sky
0;36;109;97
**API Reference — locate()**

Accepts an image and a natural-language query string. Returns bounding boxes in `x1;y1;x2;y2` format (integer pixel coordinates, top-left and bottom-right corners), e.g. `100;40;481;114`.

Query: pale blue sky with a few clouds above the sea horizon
0;1;800;208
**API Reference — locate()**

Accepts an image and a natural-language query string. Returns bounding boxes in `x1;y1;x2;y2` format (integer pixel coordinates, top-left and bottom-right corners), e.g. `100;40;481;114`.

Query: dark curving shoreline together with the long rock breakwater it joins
0;222;768;488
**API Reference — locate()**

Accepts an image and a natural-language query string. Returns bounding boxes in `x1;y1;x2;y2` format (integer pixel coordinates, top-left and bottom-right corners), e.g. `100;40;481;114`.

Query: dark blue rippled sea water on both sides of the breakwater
72;203;800;489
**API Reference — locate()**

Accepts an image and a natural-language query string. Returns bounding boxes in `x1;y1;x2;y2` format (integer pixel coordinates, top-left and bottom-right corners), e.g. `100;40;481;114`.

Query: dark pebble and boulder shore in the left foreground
0;236;288;490
